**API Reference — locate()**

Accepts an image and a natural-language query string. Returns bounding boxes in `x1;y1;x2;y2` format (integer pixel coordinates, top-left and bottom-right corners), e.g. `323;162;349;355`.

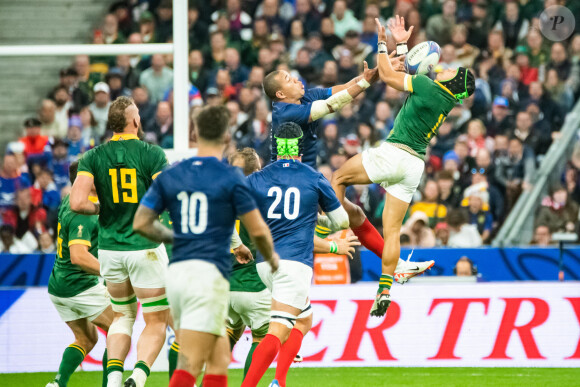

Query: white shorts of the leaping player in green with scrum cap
362;142;425;203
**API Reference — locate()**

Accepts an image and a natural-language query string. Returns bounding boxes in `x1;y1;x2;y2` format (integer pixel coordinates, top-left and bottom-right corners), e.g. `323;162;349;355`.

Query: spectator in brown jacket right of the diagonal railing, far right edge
535;186;578;233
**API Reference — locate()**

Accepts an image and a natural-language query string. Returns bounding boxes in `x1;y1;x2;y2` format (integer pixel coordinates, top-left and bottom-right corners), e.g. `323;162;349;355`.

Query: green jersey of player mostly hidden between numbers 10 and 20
230;220;266;293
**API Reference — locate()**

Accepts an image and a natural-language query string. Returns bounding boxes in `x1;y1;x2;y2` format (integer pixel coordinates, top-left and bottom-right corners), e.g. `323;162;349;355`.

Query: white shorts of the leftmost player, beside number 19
49;283;111;322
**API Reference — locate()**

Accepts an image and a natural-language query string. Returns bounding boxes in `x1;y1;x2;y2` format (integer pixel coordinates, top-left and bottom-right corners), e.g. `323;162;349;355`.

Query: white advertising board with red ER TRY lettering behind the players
0;282;580;372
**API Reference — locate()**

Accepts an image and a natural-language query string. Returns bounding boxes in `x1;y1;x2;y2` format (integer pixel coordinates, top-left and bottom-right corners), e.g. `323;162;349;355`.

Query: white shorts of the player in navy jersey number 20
256;259;312;318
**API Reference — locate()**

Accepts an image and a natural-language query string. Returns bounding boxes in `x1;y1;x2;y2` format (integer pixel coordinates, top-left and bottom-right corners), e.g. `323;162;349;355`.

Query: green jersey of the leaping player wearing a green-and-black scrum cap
386;75;457;157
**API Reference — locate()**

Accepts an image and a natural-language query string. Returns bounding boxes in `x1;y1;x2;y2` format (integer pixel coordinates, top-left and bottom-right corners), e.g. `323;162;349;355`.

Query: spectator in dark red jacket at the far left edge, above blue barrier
2;188;46;252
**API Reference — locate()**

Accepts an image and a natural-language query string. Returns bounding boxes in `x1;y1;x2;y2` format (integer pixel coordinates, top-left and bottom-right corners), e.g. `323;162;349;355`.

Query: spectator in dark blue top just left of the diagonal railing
495;137;536;212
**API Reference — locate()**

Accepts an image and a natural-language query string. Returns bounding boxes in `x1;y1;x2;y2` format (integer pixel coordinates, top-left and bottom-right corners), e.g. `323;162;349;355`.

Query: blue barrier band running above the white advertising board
0;246;580;286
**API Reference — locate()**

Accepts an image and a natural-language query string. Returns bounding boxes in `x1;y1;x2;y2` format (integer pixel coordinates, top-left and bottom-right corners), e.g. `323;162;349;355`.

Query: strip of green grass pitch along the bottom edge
0;367;580;387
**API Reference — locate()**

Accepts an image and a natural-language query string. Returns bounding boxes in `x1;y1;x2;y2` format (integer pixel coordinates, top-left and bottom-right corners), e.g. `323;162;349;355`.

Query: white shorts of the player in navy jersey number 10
165;259;230;336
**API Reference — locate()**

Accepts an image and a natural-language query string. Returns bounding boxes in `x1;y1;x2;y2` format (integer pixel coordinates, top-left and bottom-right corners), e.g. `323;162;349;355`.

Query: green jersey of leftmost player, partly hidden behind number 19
48;196;99;297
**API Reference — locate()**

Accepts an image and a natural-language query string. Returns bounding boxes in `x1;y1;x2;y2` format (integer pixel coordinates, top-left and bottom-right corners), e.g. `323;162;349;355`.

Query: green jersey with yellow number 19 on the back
78;134;167;251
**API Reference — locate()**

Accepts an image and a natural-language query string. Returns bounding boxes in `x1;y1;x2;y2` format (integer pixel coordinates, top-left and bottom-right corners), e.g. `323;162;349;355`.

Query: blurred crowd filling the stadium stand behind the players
0;0;580;253
